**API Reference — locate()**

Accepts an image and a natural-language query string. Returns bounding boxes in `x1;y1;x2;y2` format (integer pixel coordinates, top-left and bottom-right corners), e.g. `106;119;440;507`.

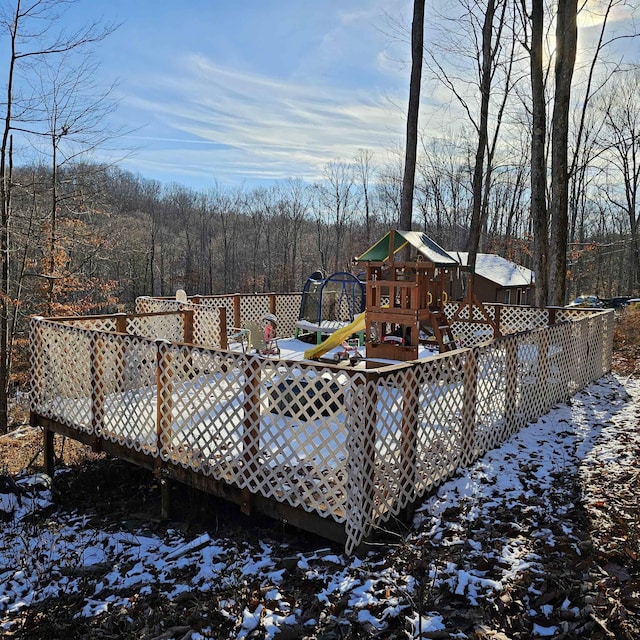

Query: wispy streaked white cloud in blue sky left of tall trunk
117;55;404;182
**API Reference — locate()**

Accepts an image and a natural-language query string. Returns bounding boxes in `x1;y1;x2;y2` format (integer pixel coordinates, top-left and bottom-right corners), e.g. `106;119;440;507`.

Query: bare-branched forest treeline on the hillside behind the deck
10;139;637;326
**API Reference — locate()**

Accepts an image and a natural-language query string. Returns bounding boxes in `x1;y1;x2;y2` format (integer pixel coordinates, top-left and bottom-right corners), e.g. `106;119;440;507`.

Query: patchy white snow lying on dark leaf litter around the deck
0;375;640;640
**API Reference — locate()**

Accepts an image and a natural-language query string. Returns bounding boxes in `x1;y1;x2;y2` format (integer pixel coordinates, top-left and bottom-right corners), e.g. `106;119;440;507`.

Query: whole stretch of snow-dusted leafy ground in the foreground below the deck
0;375;640;640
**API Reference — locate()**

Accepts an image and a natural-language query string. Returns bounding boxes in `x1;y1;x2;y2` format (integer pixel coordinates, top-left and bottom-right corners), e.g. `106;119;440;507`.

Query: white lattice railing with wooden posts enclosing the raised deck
31;297;614;553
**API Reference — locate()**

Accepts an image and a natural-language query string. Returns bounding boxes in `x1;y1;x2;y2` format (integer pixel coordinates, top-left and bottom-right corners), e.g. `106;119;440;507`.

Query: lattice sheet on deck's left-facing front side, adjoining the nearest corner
151;345;352;521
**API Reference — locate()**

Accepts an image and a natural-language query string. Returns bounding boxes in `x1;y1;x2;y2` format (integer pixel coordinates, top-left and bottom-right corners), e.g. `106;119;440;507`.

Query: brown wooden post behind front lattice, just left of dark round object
240;358;261;515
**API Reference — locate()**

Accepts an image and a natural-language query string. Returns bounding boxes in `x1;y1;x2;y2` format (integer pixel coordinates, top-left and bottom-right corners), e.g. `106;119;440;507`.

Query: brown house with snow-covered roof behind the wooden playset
449;251;535;305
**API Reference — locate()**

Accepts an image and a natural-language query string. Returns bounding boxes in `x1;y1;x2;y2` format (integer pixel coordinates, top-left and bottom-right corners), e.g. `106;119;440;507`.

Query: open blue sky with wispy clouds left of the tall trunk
69;0;412;188
